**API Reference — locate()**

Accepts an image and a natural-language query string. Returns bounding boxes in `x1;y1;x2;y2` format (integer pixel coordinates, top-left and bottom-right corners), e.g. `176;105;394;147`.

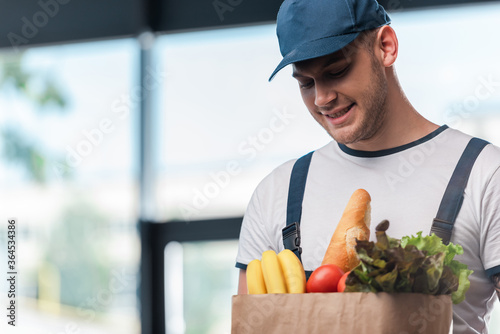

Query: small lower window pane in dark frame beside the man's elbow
165;241;238;334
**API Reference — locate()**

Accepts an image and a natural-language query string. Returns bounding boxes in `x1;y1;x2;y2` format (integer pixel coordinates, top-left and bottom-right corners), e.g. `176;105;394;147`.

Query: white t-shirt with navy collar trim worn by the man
236;126;500;333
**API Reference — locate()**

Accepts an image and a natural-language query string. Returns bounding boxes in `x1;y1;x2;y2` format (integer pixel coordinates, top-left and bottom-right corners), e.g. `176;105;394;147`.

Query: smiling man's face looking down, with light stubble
293;42;387;144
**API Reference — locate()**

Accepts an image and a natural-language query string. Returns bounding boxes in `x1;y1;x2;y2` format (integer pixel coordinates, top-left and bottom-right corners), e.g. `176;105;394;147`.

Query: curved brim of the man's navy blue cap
269;32;359;81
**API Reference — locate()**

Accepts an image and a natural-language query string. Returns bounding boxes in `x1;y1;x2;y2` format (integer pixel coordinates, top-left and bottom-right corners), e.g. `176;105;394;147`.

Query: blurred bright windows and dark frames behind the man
0;0;500;334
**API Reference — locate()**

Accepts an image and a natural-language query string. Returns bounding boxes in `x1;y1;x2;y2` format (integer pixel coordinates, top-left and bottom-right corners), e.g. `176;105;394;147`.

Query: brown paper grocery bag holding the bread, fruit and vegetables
231;292;452;334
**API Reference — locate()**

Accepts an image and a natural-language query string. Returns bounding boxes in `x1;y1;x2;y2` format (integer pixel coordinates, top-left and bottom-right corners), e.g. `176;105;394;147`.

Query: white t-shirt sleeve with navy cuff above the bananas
236;181;276;269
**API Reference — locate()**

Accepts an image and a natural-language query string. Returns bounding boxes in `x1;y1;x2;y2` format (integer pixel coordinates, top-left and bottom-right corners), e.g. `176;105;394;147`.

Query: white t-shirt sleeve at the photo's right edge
480;167;500;277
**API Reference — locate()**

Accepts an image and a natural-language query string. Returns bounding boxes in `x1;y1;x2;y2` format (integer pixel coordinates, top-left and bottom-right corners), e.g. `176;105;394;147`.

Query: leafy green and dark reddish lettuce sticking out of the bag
345;220;472;304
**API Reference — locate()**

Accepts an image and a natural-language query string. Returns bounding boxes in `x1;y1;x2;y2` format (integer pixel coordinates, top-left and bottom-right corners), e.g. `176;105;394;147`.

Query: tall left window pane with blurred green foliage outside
0;40;140;333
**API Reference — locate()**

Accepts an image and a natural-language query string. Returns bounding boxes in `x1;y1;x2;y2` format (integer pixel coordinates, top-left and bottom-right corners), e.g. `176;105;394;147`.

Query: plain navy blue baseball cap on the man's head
269;0;391;81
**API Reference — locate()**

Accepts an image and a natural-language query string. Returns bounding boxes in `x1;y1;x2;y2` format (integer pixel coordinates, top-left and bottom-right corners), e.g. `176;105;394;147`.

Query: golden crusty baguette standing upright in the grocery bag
321;189;371;272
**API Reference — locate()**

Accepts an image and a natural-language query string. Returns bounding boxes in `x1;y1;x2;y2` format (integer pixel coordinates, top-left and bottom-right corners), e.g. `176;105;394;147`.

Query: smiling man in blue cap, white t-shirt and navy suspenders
236;0;500;333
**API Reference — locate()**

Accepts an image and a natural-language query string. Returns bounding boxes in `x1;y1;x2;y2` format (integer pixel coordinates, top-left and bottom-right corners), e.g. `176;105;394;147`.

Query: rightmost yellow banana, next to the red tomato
278;249;306;293
